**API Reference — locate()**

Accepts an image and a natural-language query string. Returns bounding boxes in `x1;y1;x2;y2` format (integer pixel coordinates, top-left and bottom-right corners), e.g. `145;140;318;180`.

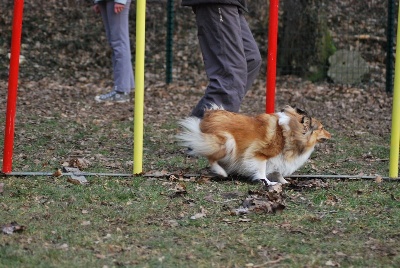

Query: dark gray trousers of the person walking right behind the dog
192;4;261;118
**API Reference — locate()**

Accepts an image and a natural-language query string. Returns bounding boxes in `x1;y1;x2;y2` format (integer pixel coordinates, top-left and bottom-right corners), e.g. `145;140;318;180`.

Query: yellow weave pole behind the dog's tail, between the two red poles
133;0;146;174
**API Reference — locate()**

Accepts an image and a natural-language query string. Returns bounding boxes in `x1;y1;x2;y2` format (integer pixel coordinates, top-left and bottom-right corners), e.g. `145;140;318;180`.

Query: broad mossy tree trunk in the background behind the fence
278;0;336;81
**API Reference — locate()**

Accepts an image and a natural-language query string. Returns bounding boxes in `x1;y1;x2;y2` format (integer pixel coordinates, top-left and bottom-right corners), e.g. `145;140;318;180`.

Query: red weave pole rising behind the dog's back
265;0;279;113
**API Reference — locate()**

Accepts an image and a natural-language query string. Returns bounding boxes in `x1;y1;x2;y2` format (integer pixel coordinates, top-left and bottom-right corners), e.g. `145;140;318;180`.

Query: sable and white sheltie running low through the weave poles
177;105;331;185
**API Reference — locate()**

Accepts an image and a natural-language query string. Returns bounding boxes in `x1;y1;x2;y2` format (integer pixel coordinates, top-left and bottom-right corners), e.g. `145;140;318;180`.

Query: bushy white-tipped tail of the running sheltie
176;117;225;157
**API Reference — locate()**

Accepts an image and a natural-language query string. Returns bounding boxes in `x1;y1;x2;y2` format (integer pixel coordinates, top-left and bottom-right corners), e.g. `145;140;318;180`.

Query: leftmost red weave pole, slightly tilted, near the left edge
3;0;24;173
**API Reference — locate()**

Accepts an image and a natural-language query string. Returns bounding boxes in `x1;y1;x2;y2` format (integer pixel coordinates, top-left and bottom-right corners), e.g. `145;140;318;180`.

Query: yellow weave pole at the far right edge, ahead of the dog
389;3;400;178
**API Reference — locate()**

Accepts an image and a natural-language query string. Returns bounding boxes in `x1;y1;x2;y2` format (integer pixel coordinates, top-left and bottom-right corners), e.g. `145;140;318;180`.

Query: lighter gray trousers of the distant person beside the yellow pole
99;1;135;93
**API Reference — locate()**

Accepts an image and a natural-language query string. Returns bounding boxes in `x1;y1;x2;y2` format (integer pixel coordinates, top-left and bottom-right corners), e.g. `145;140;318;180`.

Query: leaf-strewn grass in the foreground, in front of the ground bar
0;177;400;267
